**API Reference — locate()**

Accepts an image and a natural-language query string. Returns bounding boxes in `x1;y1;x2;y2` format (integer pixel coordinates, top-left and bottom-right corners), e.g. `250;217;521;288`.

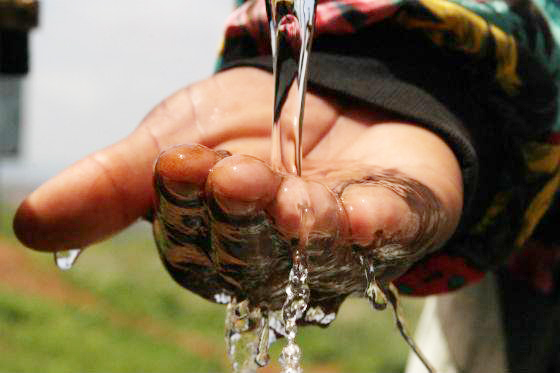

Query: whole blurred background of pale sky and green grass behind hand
0;0;421;373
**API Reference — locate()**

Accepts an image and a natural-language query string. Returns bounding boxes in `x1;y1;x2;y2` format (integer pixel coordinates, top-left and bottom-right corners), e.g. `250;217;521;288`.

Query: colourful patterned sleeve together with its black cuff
218;0;560;295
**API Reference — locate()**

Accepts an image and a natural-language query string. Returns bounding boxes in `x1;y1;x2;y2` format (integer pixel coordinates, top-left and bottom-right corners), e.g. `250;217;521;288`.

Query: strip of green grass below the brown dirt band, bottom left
0;288;221;373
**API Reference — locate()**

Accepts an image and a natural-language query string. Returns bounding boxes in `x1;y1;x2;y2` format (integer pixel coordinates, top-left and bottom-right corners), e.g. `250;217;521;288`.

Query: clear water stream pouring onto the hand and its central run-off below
266;0;316;373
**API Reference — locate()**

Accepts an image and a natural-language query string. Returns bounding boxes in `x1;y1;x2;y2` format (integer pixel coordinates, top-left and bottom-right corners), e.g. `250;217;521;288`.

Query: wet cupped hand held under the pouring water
14;68;462;310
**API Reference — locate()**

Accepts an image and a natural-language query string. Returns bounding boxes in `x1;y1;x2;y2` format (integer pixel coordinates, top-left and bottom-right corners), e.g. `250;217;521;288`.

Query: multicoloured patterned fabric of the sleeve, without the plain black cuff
218;0;560;295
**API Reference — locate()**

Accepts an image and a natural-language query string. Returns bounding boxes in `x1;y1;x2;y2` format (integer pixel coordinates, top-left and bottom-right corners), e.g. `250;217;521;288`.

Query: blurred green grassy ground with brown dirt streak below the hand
0;203;422;373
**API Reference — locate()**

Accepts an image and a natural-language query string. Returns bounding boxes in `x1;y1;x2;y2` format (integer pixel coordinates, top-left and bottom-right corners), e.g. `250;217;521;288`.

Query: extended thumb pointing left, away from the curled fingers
14;89;198;251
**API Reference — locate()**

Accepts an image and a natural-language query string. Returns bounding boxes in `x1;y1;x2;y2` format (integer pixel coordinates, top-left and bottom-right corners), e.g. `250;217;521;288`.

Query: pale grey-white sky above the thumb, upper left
0;0;233;185
